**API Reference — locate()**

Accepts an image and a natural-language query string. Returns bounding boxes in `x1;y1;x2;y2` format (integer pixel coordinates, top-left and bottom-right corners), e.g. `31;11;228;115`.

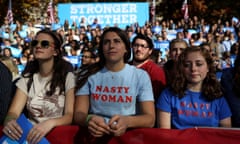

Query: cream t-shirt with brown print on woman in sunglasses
16;72;75;123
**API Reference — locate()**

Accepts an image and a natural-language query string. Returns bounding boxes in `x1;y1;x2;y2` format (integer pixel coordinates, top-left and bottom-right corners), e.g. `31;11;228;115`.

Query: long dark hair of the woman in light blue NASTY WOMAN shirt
75;27;131;91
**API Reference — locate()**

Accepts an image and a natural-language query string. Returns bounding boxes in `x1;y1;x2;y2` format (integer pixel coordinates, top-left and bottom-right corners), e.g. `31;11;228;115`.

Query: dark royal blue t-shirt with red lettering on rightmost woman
156;88;231;129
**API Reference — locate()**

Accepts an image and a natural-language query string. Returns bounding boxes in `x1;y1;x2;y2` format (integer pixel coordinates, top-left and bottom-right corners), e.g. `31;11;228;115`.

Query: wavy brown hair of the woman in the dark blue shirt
170;46;223;101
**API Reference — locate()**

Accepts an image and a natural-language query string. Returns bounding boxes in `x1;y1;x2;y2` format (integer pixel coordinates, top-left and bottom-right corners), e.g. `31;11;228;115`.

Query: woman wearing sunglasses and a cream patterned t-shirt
3;30;75;143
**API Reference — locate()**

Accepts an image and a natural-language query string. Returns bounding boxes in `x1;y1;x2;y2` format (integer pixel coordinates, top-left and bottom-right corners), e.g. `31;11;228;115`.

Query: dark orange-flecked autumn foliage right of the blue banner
156;0;240;22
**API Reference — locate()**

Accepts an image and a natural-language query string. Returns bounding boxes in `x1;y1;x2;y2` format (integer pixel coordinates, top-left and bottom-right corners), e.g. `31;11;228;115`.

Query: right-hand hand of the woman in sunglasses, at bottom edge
27;120;54;144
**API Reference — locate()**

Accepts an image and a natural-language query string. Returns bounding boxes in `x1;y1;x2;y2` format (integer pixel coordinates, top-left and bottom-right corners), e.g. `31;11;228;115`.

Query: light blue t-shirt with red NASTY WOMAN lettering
76;64;154;120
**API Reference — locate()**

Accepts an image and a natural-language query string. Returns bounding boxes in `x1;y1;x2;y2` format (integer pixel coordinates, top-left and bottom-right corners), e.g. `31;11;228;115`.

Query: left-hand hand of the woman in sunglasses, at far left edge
3;119;23;140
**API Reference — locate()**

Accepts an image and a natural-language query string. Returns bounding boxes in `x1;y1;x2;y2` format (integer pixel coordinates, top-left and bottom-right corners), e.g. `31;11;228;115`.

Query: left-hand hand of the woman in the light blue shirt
88;115;110;137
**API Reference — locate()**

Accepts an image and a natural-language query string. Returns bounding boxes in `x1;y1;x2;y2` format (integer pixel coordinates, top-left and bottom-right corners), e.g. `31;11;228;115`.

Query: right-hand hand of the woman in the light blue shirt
108;115;128;136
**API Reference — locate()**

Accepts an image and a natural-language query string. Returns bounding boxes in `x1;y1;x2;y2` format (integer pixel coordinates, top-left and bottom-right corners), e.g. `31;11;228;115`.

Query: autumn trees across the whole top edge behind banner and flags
0;0;240;25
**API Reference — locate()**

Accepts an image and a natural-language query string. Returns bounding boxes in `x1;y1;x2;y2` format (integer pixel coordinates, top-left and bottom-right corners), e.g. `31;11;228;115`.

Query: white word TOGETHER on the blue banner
70;14;137;24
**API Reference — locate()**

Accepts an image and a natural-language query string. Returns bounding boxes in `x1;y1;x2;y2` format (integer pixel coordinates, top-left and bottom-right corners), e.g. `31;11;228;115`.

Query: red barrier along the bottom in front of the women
0;126;240;144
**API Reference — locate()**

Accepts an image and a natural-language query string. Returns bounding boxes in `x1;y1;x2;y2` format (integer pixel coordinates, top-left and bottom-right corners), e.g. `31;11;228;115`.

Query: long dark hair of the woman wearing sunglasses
22;29;70;96
